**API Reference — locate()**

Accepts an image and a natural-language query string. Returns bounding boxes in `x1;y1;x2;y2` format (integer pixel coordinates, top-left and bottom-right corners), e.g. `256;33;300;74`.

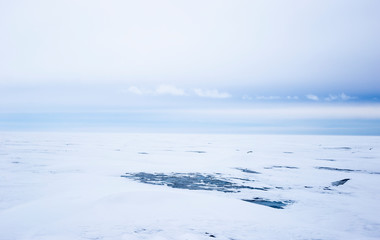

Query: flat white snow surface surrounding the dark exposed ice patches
0;132;380;240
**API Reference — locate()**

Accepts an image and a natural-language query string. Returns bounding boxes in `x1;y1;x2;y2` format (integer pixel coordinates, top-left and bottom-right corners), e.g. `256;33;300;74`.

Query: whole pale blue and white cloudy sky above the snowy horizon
0;0;380;135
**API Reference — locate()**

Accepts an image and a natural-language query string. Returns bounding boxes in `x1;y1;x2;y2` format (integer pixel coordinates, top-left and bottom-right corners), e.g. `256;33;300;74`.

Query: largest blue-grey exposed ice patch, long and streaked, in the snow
121;172;269;193
